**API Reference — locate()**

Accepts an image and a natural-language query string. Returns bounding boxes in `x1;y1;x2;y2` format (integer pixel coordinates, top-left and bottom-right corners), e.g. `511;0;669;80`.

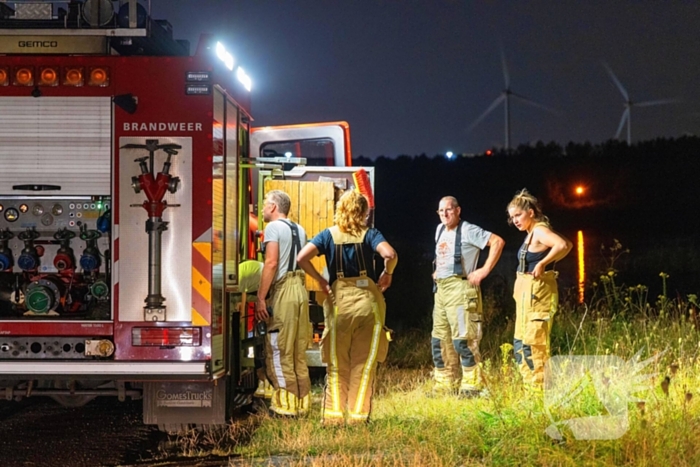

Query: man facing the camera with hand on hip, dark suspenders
431;196;505;397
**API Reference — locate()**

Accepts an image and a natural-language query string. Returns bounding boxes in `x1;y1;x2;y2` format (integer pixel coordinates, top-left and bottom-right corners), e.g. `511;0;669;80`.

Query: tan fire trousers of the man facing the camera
431;276;483;392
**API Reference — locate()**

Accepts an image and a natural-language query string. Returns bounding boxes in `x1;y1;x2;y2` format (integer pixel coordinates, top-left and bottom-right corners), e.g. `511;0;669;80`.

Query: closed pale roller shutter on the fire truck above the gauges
0;97;112;196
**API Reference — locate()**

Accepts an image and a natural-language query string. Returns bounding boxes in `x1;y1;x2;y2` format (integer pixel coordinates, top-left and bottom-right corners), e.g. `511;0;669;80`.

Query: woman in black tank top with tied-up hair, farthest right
508;189;572;387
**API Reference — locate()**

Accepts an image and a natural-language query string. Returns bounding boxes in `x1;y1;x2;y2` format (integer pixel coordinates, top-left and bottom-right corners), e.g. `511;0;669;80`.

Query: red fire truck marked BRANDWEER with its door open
0;0;372;429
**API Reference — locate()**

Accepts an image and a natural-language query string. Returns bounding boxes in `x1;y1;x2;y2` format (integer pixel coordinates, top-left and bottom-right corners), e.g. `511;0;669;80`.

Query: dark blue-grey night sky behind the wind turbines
152;0;700;158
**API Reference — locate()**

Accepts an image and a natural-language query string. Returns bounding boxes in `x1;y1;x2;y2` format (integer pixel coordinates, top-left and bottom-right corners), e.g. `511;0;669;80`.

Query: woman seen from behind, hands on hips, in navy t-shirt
297;191;398;424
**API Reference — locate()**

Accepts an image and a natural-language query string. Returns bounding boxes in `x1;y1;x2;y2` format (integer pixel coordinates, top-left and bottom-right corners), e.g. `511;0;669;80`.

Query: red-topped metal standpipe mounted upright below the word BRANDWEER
122;139;182;321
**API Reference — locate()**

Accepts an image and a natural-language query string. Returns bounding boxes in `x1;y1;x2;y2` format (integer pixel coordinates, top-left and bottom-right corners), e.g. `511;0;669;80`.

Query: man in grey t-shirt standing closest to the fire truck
255;190;311;416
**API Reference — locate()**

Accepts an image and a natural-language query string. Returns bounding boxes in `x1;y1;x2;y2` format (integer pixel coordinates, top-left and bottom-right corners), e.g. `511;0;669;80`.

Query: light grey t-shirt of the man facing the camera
435;221;491;279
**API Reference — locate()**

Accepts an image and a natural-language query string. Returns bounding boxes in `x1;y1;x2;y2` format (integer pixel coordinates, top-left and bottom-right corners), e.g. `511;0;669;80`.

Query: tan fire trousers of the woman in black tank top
513;271;559;385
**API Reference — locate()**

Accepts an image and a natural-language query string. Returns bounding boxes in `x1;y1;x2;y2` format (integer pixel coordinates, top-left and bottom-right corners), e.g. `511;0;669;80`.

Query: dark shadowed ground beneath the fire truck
0;398;191;467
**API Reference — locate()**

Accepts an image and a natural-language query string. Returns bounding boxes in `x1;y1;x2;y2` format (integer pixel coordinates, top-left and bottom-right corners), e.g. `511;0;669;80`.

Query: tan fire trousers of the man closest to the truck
265;271;311;415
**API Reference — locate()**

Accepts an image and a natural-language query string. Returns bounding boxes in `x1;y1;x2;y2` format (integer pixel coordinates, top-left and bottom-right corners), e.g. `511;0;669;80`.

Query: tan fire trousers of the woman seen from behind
321;276;389;424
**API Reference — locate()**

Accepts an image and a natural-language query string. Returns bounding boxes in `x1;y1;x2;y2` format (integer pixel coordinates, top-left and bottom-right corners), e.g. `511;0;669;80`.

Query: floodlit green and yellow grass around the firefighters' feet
161;268;700;467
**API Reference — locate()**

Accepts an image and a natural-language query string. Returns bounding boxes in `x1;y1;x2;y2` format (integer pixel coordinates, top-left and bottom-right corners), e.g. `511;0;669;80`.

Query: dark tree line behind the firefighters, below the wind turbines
353;137;700;325
